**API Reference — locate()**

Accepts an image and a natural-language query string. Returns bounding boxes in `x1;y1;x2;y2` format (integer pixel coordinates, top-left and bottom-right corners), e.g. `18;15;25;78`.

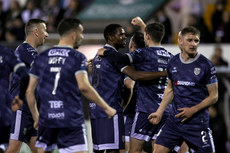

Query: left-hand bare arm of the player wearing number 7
26;76;39;129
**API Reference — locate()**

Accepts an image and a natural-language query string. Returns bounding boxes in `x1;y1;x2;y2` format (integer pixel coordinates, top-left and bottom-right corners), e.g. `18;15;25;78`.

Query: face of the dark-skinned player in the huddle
113;27;126;48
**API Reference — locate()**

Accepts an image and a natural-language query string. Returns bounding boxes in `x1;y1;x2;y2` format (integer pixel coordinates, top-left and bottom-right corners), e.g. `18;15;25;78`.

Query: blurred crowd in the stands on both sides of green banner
0;0;230;43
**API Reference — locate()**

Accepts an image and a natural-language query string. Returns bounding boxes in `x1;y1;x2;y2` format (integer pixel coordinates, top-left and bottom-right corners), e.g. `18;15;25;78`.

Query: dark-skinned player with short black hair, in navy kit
90;24;126;153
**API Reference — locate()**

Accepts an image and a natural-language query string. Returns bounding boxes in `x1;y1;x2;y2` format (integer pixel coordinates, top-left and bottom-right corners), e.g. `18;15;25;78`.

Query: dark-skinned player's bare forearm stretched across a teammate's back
122;66;167;81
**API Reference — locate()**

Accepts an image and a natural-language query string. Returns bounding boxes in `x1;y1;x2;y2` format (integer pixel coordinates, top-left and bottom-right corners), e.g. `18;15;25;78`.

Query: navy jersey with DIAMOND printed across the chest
168;54;217;128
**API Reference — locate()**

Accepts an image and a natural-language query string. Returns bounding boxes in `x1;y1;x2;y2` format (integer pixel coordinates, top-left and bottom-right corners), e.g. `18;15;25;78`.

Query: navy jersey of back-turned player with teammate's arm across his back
128;46;173;113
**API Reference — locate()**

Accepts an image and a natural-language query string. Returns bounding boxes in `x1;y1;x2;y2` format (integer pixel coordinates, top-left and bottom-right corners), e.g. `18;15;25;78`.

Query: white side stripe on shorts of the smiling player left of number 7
10;110;22;140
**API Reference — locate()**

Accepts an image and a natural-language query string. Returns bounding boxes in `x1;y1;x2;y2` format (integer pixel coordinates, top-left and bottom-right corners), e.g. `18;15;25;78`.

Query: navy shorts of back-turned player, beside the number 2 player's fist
131;112;168;141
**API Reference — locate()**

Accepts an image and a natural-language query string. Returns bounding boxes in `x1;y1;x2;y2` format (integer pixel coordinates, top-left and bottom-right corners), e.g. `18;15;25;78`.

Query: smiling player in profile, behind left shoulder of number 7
7;19;48;153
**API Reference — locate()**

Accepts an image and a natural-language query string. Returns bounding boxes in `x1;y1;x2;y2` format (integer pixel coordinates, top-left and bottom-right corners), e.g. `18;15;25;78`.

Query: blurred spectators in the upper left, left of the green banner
0;0;93;42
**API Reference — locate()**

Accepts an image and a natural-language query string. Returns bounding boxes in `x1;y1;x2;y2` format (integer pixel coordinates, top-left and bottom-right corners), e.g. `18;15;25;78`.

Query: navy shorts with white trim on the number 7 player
35;124;88;153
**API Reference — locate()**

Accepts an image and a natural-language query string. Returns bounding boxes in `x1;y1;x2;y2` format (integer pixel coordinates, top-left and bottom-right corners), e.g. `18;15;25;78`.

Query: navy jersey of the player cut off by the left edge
0;46;24;126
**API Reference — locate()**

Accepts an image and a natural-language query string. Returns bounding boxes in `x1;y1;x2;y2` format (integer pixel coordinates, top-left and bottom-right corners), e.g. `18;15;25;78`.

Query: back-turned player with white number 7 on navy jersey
26;18;116;153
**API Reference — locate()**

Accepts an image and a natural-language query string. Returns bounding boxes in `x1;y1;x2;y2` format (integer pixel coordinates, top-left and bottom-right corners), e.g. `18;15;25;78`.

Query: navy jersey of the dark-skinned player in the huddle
90;45;124;119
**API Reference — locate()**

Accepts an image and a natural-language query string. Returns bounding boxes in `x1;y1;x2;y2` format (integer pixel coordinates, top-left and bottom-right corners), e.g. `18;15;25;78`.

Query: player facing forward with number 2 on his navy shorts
149;27;218;153
